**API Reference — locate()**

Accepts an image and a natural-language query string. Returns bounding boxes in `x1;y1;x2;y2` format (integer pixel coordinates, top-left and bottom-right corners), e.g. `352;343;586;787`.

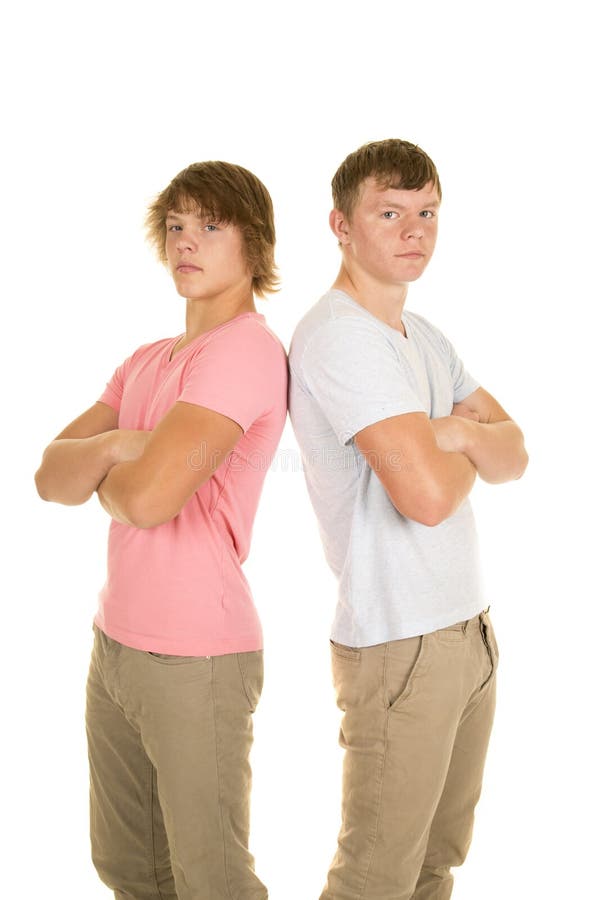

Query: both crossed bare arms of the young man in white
354;388;528;525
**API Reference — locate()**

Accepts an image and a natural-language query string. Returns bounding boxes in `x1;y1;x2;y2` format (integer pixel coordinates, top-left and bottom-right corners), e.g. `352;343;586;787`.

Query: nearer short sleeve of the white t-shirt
300;316;426;445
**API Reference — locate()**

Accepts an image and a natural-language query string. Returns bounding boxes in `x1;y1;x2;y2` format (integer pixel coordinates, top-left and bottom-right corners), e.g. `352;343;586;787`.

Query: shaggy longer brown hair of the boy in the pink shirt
146;160;278;297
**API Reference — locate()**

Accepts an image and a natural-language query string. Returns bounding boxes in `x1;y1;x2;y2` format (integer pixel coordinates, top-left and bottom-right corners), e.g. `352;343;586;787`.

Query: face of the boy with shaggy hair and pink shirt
165;211;252;300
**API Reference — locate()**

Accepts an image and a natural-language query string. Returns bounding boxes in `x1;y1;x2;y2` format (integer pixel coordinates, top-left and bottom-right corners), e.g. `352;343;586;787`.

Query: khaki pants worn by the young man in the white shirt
321;613;498;900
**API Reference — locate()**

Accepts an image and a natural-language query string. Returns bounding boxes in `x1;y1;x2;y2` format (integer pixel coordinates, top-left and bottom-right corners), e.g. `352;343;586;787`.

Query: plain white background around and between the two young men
0;0;600;900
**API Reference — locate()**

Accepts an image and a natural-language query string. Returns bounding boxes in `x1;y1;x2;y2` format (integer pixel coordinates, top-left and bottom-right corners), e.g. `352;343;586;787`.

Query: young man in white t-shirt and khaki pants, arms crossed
290;139;527;900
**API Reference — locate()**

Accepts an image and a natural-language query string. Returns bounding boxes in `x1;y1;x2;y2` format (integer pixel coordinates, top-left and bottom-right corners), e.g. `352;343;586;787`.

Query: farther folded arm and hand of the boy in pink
35;402;148;506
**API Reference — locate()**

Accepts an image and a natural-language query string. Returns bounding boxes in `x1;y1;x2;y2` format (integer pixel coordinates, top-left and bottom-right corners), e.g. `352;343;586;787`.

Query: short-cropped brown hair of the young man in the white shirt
331;138;442;218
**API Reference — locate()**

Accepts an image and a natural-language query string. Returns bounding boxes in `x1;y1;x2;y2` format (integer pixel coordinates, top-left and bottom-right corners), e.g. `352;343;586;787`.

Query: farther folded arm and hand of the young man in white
431;388;529;484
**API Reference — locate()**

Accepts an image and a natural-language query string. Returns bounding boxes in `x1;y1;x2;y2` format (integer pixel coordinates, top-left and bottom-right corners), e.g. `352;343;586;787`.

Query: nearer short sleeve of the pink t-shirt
177;319;287;432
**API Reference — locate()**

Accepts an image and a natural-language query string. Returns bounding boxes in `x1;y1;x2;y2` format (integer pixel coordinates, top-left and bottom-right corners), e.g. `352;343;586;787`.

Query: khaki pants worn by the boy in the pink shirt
86;629;267;900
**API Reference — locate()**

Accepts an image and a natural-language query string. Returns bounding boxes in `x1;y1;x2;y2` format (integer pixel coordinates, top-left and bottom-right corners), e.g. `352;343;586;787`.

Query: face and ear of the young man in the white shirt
331;178;440;286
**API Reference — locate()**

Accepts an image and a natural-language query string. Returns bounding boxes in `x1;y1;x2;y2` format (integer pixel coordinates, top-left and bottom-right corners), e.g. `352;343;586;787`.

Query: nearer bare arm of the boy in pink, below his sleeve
98;401;243;528
